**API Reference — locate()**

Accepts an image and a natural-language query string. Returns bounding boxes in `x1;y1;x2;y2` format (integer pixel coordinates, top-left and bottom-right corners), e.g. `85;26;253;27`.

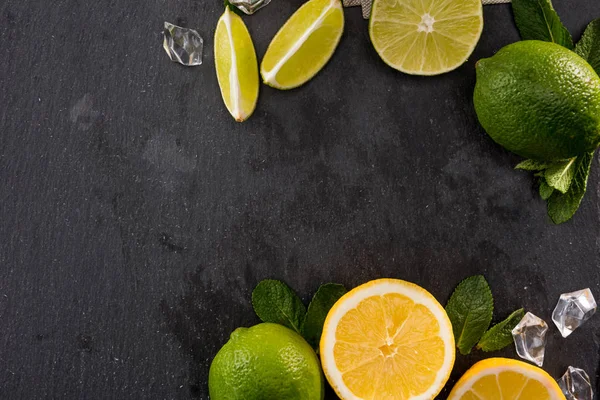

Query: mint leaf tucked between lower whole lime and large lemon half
302;283;346;349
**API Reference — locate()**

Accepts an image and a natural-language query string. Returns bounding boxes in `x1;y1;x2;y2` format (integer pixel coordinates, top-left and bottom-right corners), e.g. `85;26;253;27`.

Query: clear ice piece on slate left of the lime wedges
163;21;204;67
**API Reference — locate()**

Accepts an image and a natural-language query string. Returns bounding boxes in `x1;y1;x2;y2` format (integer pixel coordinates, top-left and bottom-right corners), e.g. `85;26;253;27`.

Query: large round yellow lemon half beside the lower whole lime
320;279;455;400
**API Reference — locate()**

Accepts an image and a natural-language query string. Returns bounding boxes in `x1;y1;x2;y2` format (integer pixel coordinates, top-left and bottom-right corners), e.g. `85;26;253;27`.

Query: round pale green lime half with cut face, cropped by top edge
369;0;483;75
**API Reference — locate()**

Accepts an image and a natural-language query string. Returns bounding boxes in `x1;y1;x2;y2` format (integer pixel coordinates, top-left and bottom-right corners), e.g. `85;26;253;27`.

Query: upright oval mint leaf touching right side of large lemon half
446;275;494;354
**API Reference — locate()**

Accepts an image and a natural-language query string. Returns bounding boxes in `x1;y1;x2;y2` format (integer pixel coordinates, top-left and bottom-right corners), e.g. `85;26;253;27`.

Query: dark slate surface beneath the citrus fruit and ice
0;0;600;399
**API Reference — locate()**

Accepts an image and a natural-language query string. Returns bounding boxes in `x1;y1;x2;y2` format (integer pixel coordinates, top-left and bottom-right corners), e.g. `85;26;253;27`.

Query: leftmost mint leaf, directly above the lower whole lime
252;279;306;333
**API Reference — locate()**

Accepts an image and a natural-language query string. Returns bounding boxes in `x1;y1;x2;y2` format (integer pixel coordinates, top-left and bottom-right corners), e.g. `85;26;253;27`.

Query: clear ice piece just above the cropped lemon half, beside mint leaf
512;312;548;367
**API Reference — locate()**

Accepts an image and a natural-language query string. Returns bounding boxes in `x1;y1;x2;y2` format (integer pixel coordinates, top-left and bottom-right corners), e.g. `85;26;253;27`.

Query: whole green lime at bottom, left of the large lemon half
208;323;325;400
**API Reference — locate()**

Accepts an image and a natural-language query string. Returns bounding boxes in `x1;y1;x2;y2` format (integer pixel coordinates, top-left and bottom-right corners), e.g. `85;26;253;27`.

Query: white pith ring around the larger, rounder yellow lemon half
321;281;454;400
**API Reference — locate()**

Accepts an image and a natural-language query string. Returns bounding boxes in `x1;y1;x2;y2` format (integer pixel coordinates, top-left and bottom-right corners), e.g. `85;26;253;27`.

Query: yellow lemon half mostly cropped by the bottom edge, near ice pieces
448;358;565;400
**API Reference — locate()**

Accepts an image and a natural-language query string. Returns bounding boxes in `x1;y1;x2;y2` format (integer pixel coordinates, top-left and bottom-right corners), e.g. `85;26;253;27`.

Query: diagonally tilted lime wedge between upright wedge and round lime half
260;0;344;89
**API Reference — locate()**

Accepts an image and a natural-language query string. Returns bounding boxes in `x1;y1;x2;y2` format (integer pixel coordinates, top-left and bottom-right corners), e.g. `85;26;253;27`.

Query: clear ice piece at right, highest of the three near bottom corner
552;289;596;337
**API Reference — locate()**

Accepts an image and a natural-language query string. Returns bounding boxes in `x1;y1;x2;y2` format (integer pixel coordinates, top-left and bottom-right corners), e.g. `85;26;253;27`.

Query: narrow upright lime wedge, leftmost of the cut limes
215;7;259;122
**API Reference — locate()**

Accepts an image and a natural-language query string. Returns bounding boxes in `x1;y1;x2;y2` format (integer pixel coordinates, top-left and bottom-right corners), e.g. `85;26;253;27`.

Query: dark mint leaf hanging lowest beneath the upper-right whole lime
548;153;594;224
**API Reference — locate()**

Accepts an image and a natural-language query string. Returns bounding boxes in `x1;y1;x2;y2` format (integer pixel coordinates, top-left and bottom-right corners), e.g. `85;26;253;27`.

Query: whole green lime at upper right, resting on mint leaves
473;40;600;161
